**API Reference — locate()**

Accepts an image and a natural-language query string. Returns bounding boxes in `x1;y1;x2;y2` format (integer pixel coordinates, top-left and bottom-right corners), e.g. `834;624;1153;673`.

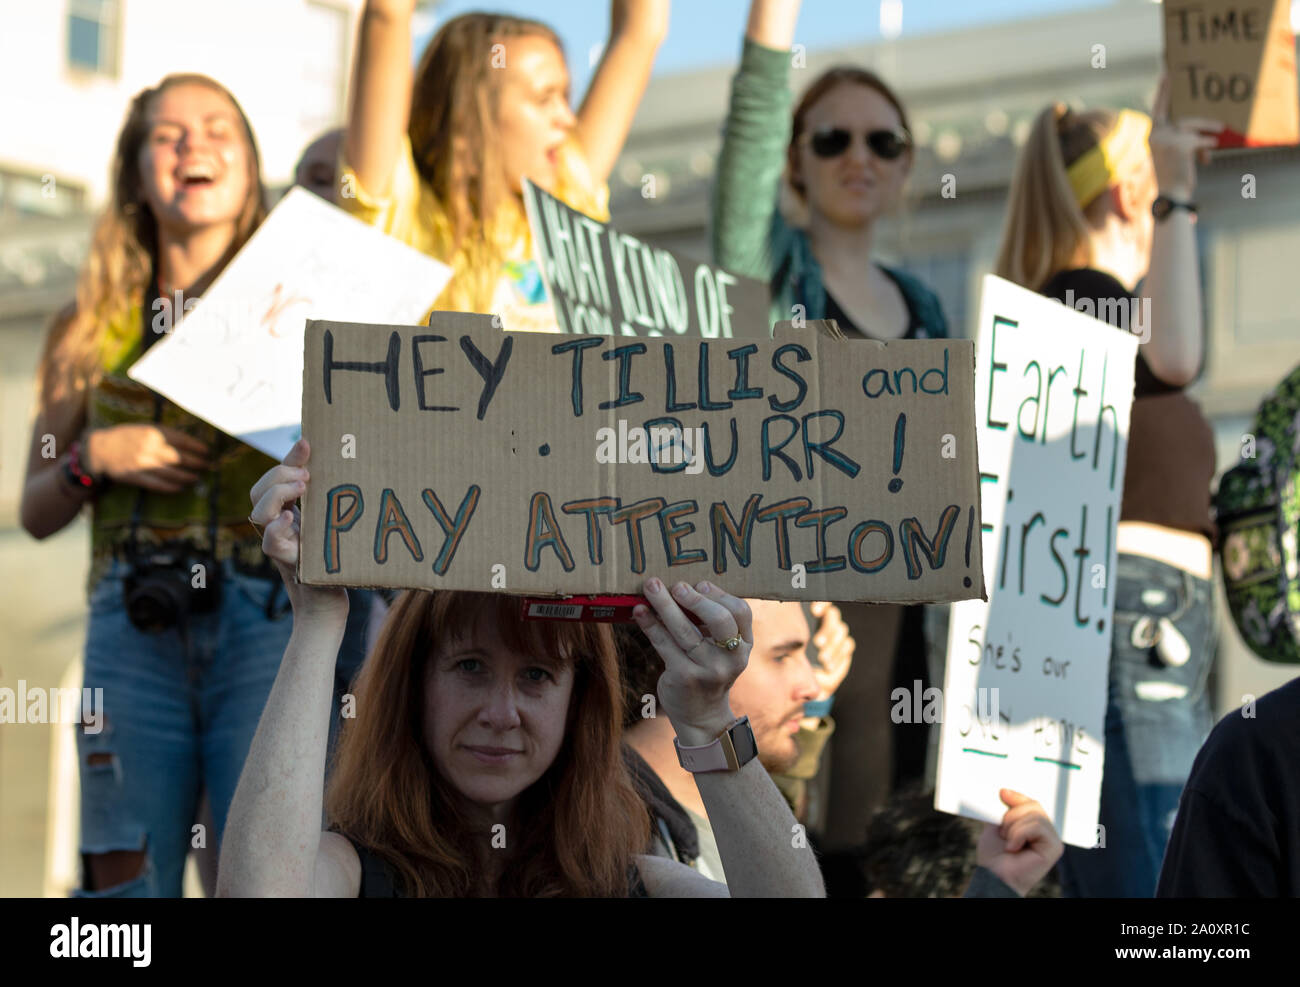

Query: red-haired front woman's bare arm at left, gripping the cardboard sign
217;440;361;897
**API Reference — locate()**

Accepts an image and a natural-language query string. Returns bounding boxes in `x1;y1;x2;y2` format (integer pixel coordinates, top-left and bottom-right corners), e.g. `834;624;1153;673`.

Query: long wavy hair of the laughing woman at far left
39;73;267;407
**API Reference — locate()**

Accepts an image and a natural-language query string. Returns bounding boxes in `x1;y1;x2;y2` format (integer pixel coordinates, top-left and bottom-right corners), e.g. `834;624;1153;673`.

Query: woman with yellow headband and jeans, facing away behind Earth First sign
995;85;1222;897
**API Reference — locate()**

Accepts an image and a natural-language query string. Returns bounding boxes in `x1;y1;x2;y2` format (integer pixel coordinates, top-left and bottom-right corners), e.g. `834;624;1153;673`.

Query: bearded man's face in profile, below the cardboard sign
731;599;818;774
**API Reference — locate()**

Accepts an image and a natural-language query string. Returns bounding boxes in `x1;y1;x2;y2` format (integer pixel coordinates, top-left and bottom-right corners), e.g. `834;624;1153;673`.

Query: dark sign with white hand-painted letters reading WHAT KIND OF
524;179;771;339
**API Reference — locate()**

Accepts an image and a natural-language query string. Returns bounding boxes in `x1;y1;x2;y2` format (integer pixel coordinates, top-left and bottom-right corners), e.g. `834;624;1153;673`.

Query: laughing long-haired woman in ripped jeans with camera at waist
22;74;364;897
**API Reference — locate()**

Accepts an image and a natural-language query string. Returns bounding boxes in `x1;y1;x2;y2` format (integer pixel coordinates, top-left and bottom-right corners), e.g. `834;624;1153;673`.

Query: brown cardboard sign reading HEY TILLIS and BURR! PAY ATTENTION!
300;312;984;602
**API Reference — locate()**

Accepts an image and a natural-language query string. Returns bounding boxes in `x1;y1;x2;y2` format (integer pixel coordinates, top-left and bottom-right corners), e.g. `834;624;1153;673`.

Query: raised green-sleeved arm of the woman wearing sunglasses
711;0;800;282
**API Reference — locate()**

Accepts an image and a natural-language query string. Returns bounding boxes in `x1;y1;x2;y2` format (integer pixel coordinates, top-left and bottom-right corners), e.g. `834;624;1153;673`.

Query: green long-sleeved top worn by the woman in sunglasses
712;38;949;338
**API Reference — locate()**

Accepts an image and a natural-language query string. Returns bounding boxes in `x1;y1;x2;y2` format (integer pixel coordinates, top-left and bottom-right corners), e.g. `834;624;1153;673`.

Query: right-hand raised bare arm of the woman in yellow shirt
577;0;668;182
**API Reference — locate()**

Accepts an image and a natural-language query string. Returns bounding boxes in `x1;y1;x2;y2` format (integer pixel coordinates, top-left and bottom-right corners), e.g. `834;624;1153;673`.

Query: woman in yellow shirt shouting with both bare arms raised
341;0;668;332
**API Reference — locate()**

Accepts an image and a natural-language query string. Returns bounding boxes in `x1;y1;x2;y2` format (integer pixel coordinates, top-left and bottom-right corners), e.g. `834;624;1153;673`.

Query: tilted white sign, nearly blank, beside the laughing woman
127;189;451;459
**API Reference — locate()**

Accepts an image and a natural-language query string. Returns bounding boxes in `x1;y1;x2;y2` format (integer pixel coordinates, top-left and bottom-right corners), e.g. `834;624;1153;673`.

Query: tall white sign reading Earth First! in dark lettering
935;274;1147;847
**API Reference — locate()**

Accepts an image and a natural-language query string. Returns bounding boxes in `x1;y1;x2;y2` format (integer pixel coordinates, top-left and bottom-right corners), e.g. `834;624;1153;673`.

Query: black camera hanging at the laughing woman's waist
124;546;221;631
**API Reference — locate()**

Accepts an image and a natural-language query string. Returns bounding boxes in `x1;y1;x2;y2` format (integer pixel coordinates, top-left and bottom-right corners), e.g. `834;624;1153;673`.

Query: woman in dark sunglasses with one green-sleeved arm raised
712;0;948;339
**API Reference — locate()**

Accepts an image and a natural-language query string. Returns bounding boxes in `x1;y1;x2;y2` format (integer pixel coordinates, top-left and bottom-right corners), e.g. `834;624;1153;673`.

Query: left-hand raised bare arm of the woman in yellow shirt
343;0;415;199
